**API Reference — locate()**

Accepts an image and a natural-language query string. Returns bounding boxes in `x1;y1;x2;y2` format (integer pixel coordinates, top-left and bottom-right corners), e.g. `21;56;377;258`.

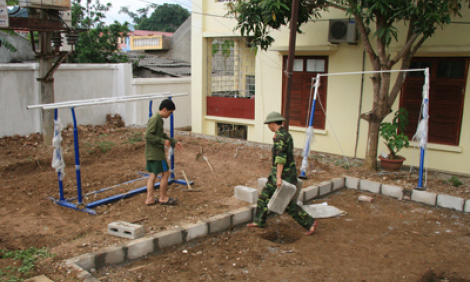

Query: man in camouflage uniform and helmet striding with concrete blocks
247;112;317;235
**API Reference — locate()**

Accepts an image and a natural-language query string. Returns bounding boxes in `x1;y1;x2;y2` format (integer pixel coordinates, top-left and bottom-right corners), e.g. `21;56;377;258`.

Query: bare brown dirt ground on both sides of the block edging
0;121;470;282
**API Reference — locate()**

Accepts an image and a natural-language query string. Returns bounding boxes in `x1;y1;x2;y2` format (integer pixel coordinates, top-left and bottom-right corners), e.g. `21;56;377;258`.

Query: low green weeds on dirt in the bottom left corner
0;247;52;281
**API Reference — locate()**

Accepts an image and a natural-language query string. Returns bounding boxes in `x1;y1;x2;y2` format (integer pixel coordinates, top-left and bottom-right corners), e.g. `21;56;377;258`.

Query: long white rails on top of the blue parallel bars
26;92;189;110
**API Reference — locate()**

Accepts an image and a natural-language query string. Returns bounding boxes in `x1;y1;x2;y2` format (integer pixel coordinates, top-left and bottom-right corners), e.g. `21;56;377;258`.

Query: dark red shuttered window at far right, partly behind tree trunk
400;57;469;145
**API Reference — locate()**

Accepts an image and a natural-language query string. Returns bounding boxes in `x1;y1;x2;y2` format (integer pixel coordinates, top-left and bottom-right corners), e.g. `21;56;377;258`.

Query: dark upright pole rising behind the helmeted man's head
283;0;299;131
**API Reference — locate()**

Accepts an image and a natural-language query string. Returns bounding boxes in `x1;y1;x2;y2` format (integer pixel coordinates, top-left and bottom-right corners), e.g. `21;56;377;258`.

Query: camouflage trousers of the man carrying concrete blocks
255;177;315;230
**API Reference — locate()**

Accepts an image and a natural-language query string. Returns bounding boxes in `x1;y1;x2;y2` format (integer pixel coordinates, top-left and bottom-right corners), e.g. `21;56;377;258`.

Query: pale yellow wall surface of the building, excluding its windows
192;0;470;174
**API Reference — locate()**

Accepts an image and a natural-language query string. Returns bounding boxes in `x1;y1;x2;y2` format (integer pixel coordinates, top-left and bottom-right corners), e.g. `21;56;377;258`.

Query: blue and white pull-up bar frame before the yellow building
300;68;429;190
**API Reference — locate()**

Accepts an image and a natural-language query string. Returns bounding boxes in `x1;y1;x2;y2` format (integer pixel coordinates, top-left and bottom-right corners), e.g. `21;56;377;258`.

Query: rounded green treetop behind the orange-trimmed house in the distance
134;3;190;32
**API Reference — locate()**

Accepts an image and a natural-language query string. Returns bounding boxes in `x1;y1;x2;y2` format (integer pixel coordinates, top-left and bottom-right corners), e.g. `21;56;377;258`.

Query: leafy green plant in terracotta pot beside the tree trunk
379;108;410;171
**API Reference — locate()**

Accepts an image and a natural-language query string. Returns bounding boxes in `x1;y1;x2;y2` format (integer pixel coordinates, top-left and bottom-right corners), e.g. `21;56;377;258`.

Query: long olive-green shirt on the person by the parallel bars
145;112;176;161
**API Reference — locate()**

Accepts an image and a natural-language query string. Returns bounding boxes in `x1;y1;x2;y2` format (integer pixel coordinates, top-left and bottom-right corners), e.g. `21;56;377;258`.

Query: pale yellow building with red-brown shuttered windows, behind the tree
191;0;470;174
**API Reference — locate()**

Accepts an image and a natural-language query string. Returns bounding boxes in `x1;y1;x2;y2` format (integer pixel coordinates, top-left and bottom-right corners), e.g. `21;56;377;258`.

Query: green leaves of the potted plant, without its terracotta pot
379;108;410;160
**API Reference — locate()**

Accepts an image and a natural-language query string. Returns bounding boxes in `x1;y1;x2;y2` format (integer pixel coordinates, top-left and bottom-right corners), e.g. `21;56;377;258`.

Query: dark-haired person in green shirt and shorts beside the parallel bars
145;99;183;206
